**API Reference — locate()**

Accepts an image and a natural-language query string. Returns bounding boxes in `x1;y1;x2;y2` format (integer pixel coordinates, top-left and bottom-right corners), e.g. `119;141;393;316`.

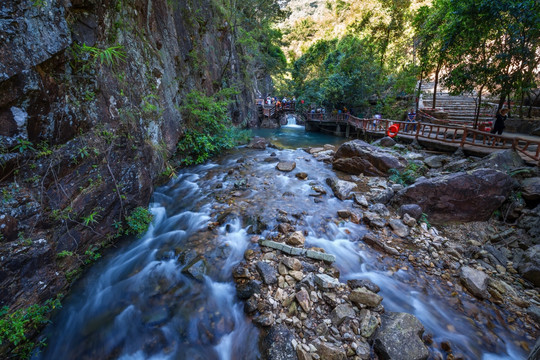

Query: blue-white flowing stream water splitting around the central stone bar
35;124;526;360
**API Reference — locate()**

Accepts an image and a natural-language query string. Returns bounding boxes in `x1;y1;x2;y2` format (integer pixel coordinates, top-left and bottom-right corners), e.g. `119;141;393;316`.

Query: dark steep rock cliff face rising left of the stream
0;0;262;326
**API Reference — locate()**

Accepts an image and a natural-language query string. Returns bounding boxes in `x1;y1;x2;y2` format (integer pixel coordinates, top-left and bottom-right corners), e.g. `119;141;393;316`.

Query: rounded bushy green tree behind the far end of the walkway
292;35;416;114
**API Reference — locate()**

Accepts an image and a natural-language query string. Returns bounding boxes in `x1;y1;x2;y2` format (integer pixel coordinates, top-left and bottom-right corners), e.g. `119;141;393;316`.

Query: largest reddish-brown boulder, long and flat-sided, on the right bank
395;169;514;224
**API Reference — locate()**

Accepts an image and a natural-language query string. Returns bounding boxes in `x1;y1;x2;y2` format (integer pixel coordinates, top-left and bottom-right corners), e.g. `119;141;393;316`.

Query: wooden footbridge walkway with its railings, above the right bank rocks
304;113;540;166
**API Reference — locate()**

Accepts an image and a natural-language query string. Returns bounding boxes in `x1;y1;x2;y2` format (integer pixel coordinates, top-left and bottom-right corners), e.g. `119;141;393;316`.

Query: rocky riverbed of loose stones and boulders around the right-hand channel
233;139;540;359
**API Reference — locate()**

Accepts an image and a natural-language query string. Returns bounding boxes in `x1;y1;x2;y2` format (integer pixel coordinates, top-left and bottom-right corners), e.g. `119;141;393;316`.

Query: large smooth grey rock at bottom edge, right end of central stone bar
374;312;429;360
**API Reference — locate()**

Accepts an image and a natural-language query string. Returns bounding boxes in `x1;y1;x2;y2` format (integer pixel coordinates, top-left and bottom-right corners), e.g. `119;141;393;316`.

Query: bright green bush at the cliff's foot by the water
177;89;244;165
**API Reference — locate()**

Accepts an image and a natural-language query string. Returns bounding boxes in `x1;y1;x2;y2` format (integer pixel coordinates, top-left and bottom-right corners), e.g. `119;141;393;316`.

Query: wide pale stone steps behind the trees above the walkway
419;82;497;125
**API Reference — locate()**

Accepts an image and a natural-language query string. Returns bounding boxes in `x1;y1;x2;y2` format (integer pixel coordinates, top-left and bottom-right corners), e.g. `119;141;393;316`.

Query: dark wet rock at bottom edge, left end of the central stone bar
261;325;298;360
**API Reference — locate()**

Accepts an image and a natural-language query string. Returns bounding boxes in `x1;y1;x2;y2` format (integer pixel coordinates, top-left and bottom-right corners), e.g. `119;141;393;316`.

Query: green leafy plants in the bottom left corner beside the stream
0;298;61;359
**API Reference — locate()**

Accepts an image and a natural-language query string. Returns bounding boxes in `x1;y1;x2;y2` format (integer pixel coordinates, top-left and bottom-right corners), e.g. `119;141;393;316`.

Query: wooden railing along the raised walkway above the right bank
304;113;540;166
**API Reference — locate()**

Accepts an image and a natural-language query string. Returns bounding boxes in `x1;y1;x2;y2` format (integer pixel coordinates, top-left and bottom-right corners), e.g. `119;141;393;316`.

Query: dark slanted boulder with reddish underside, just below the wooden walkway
332;140;406;176
